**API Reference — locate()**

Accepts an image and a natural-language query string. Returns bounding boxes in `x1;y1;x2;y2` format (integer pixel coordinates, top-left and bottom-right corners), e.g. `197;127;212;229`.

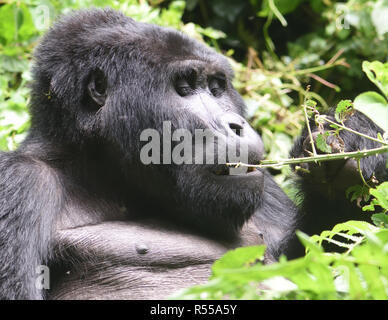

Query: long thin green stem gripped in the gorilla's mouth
226;146;388;168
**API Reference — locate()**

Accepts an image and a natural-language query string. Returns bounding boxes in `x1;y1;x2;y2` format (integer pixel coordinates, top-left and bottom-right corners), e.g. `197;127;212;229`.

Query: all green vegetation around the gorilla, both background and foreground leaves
0;0;388;299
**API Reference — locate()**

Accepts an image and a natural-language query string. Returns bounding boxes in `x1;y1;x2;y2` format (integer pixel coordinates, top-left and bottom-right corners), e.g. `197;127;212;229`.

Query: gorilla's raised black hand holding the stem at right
291;111;386;198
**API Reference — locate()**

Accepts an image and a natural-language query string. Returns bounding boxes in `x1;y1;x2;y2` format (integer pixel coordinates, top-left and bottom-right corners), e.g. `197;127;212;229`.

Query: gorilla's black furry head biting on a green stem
32;10;264;238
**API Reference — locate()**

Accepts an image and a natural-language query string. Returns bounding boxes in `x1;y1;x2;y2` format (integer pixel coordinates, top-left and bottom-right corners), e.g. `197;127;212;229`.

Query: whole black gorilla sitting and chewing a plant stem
0;9;387;299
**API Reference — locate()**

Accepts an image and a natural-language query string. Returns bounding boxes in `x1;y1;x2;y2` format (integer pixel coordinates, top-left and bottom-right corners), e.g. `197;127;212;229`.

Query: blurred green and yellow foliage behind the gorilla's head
0;0;388;191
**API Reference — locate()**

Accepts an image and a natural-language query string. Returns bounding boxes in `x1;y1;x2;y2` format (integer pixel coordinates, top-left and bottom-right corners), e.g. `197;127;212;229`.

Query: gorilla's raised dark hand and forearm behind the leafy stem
289;111;388;257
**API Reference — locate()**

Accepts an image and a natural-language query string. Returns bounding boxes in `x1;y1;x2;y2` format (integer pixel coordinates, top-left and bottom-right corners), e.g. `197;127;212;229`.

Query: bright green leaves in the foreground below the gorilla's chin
172;182;388;300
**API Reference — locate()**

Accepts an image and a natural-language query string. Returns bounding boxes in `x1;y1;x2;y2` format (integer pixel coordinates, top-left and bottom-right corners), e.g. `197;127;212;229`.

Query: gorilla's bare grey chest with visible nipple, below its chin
49;220;269;299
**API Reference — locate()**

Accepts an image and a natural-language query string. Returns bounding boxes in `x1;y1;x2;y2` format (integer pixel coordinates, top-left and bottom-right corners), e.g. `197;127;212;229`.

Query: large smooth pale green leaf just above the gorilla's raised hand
354;91;388;132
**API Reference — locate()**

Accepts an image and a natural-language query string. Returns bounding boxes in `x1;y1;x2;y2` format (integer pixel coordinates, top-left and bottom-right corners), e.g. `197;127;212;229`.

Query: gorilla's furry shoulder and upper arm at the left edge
0;152;62;299
